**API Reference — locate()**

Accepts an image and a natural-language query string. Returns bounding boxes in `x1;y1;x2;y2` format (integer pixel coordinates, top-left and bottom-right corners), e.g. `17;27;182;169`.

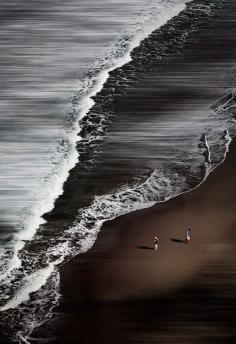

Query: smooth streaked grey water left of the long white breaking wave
0;0;157;232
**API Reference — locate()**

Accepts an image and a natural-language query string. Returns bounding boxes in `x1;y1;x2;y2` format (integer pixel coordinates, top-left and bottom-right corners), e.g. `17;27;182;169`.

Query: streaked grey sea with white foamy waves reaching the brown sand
0;0;234;342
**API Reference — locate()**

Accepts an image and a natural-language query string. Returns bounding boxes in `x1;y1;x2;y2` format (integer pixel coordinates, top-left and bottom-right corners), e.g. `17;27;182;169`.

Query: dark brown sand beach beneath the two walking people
43;141;236;344
